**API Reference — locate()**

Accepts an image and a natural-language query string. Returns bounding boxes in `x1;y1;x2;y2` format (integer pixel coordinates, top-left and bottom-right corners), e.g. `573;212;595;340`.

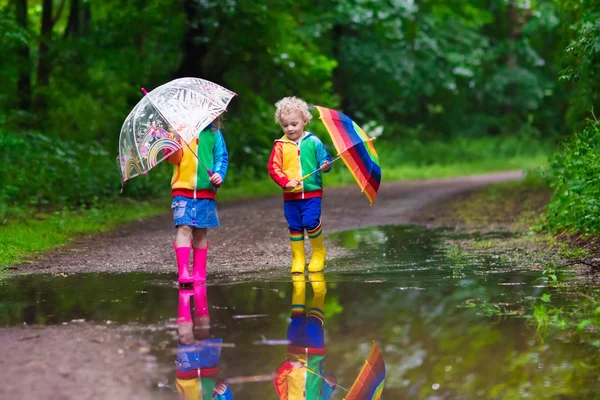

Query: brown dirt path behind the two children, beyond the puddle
15;171;523;278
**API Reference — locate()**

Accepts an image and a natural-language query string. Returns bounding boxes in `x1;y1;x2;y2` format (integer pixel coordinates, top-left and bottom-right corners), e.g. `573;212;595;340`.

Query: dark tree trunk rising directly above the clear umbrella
176;0;208;77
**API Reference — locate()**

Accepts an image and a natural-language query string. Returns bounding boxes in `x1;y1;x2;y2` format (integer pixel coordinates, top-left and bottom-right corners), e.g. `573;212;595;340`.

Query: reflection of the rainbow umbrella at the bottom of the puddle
344;342;385;400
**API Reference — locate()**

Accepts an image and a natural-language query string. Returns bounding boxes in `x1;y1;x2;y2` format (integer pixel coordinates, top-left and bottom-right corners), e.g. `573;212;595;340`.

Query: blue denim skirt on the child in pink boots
171;196;221;228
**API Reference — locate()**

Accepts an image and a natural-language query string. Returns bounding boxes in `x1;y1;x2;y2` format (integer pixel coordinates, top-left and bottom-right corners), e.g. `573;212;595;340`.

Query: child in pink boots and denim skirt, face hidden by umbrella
167;117;228;284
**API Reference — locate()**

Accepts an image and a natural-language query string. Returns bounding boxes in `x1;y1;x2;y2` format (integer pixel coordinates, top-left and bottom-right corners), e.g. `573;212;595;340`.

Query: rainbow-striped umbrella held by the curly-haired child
315;106;381;205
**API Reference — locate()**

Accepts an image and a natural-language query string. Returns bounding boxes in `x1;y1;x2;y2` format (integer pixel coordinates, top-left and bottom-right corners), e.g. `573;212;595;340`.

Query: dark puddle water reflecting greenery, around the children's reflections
0;226;600;399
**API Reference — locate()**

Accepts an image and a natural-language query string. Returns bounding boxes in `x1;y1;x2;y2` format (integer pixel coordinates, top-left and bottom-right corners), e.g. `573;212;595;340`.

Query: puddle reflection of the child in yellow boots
274;273;337;400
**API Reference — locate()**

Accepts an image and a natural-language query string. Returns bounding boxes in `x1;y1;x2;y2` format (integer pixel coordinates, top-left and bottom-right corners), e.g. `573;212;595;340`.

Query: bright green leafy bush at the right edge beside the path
547;122;600;234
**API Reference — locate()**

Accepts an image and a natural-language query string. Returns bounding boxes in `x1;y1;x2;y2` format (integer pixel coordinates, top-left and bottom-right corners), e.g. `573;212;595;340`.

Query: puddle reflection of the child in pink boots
175;285;233;400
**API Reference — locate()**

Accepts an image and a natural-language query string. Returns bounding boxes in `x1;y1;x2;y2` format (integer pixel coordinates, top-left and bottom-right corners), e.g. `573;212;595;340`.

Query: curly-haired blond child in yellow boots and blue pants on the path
269;97;331;273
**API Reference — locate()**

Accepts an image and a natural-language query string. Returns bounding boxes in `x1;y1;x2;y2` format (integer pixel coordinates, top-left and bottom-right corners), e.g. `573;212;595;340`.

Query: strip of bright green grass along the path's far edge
0;155;545;269
